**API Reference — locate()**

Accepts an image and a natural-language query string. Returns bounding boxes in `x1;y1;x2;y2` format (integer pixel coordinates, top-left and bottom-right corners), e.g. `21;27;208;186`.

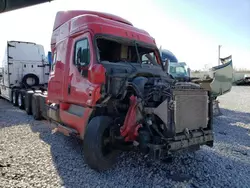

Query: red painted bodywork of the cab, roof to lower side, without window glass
48;11;156;138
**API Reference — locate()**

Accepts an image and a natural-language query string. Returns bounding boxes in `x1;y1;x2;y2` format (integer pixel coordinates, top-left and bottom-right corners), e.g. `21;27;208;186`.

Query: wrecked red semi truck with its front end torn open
21;11;213;171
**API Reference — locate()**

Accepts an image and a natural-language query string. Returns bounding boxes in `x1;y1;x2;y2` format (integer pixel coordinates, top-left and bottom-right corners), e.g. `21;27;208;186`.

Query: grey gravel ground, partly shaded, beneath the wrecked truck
0;86;250;188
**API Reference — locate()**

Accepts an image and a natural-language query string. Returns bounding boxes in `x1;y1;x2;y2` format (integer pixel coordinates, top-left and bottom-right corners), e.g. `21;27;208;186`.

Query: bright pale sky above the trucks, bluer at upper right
0;0;250;69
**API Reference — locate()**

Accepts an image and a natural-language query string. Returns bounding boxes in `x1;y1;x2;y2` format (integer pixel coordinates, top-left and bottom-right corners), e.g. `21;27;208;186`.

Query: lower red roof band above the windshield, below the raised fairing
51;11;155;48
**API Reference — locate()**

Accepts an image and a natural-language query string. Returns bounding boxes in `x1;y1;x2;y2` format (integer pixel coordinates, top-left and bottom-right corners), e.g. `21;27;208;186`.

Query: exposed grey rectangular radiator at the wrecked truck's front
173;89;209;133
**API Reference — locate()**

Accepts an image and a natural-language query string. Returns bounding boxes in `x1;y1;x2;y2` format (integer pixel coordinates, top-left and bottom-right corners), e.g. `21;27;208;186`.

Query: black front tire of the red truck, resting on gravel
83;116;119;172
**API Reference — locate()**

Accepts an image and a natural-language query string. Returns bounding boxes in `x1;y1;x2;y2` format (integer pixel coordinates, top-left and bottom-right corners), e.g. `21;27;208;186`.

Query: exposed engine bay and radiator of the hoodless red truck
97;61;213;155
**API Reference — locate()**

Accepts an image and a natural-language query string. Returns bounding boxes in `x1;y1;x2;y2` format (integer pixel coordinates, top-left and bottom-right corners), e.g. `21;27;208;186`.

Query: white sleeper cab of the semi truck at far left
0;41;49;108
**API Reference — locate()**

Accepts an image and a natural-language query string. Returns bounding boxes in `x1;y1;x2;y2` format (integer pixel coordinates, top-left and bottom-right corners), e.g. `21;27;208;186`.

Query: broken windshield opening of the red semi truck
96;38;160;66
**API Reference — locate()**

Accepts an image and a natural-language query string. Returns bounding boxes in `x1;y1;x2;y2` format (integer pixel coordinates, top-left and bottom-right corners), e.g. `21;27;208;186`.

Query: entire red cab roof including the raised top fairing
51;10;155;48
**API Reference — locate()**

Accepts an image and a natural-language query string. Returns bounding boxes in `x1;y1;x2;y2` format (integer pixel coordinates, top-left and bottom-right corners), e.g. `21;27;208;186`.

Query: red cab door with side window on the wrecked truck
66;33;93;106
